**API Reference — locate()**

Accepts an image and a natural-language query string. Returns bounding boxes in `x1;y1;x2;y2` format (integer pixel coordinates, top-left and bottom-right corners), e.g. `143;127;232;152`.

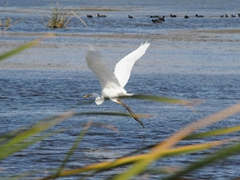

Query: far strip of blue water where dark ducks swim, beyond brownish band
0;0;240;34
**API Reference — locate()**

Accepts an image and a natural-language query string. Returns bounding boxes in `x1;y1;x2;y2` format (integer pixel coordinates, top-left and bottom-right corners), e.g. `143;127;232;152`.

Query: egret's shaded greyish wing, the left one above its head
86;46;120;89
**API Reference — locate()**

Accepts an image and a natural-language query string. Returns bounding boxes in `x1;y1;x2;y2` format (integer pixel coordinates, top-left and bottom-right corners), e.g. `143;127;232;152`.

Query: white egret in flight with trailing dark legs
84;42;150;128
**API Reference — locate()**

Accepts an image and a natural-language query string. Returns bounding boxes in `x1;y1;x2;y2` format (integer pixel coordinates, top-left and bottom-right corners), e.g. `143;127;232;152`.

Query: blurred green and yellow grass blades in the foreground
0;39;240;180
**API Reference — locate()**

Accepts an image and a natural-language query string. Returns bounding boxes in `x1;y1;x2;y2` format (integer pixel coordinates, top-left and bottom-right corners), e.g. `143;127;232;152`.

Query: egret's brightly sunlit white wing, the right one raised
114;42;150;87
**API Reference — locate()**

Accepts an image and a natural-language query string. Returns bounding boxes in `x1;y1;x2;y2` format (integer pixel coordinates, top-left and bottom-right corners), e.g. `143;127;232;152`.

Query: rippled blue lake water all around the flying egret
0;0;240;180
